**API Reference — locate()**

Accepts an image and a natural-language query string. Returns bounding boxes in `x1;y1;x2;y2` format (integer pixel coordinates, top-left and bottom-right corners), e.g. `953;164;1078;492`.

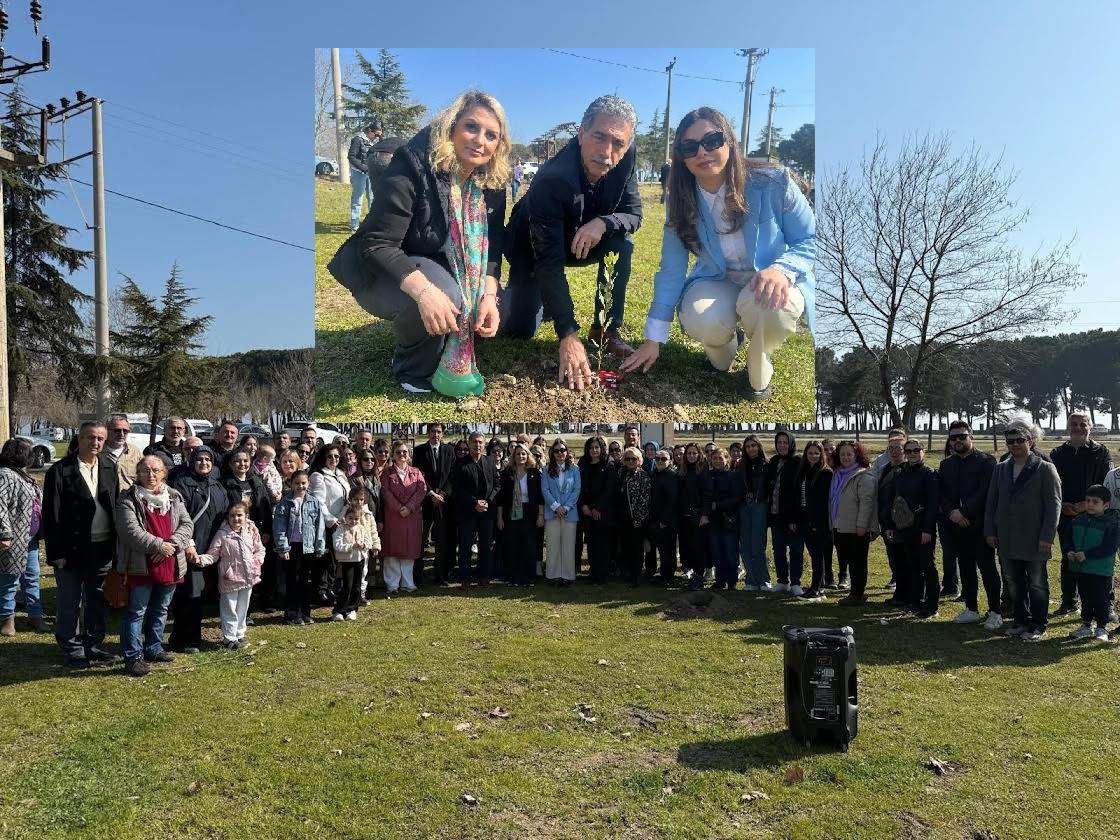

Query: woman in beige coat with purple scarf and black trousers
829;440;878;605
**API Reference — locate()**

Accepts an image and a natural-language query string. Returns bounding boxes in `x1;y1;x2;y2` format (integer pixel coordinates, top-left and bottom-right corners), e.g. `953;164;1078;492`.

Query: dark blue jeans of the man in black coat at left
55;542;112;660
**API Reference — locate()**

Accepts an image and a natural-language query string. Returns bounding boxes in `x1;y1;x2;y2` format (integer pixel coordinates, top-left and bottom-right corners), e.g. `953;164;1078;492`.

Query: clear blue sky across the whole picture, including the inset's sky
4;0;1120;353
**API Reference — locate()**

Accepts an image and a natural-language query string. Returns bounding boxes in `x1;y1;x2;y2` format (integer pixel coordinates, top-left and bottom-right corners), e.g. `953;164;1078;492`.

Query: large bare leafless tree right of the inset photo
816;136;1084;428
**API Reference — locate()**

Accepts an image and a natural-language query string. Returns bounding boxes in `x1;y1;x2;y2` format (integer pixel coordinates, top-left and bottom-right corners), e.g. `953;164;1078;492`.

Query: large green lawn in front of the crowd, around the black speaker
0;542;1120;840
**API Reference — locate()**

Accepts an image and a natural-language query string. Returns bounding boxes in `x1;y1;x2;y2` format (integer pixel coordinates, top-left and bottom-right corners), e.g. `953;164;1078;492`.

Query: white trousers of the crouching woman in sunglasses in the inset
681;271;805;391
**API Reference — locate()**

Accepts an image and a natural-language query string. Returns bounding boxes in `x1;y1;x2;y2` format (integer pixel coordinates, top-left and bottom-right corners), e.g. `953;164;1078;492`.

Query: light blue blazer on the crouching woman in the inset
648;167;816;329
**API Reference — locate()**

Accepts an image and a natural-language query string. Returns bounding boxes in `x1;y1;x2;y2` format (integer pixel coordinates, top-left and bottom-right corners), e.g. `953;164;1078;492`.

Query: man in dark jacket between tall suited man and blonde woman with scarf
451;431;498;589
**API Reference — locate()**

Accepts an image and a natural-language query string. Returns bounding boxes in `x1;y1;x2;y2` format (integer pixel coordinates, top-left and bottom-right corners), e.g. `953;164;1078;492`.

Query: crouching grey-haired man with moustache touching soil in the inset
501;94;642;391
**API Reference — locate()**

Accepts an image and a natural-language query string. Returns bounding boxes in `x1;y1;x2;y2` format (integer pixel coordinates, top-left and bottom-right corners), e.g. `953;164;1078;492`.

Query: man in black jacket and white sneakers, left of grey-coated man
937;420;1004;631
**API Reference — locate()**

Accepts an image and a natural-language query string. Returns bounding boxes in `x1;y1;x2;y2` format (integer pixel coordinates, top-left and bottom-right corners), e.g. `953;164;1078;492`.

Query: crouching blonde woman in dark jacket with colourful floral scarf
339;91;512;396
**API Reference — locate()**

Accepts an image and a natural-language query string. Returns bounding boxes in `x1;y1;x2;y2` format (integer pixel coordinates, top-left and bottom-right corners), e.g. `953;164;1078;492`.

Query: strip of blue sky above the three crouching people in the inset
339;45;815;156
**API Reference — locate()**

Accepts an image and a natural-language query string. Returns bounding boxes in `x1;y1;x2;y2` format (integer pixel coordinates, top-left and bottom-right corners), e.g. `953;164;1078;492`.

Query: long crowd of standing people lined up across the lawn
0;414;1120;675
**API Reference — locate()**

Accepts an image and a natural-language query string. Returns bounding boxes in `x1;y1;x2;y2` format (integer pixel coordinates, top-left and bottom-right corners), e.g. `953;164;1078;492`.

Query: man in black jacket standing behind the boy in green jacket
1051;414;1116;620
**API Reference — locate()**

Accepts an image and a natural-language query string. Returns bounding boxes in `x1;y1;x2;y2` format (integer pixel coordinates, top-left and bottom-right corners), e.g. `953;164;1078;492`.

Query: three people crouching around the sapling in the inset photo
328;91;815;400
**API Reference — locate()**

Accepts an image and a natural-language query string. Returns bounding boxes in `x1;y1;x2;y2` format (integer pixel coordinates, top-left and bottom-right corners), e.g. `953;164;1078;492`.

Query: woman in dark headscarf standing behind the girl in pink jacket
168;446;230;653
